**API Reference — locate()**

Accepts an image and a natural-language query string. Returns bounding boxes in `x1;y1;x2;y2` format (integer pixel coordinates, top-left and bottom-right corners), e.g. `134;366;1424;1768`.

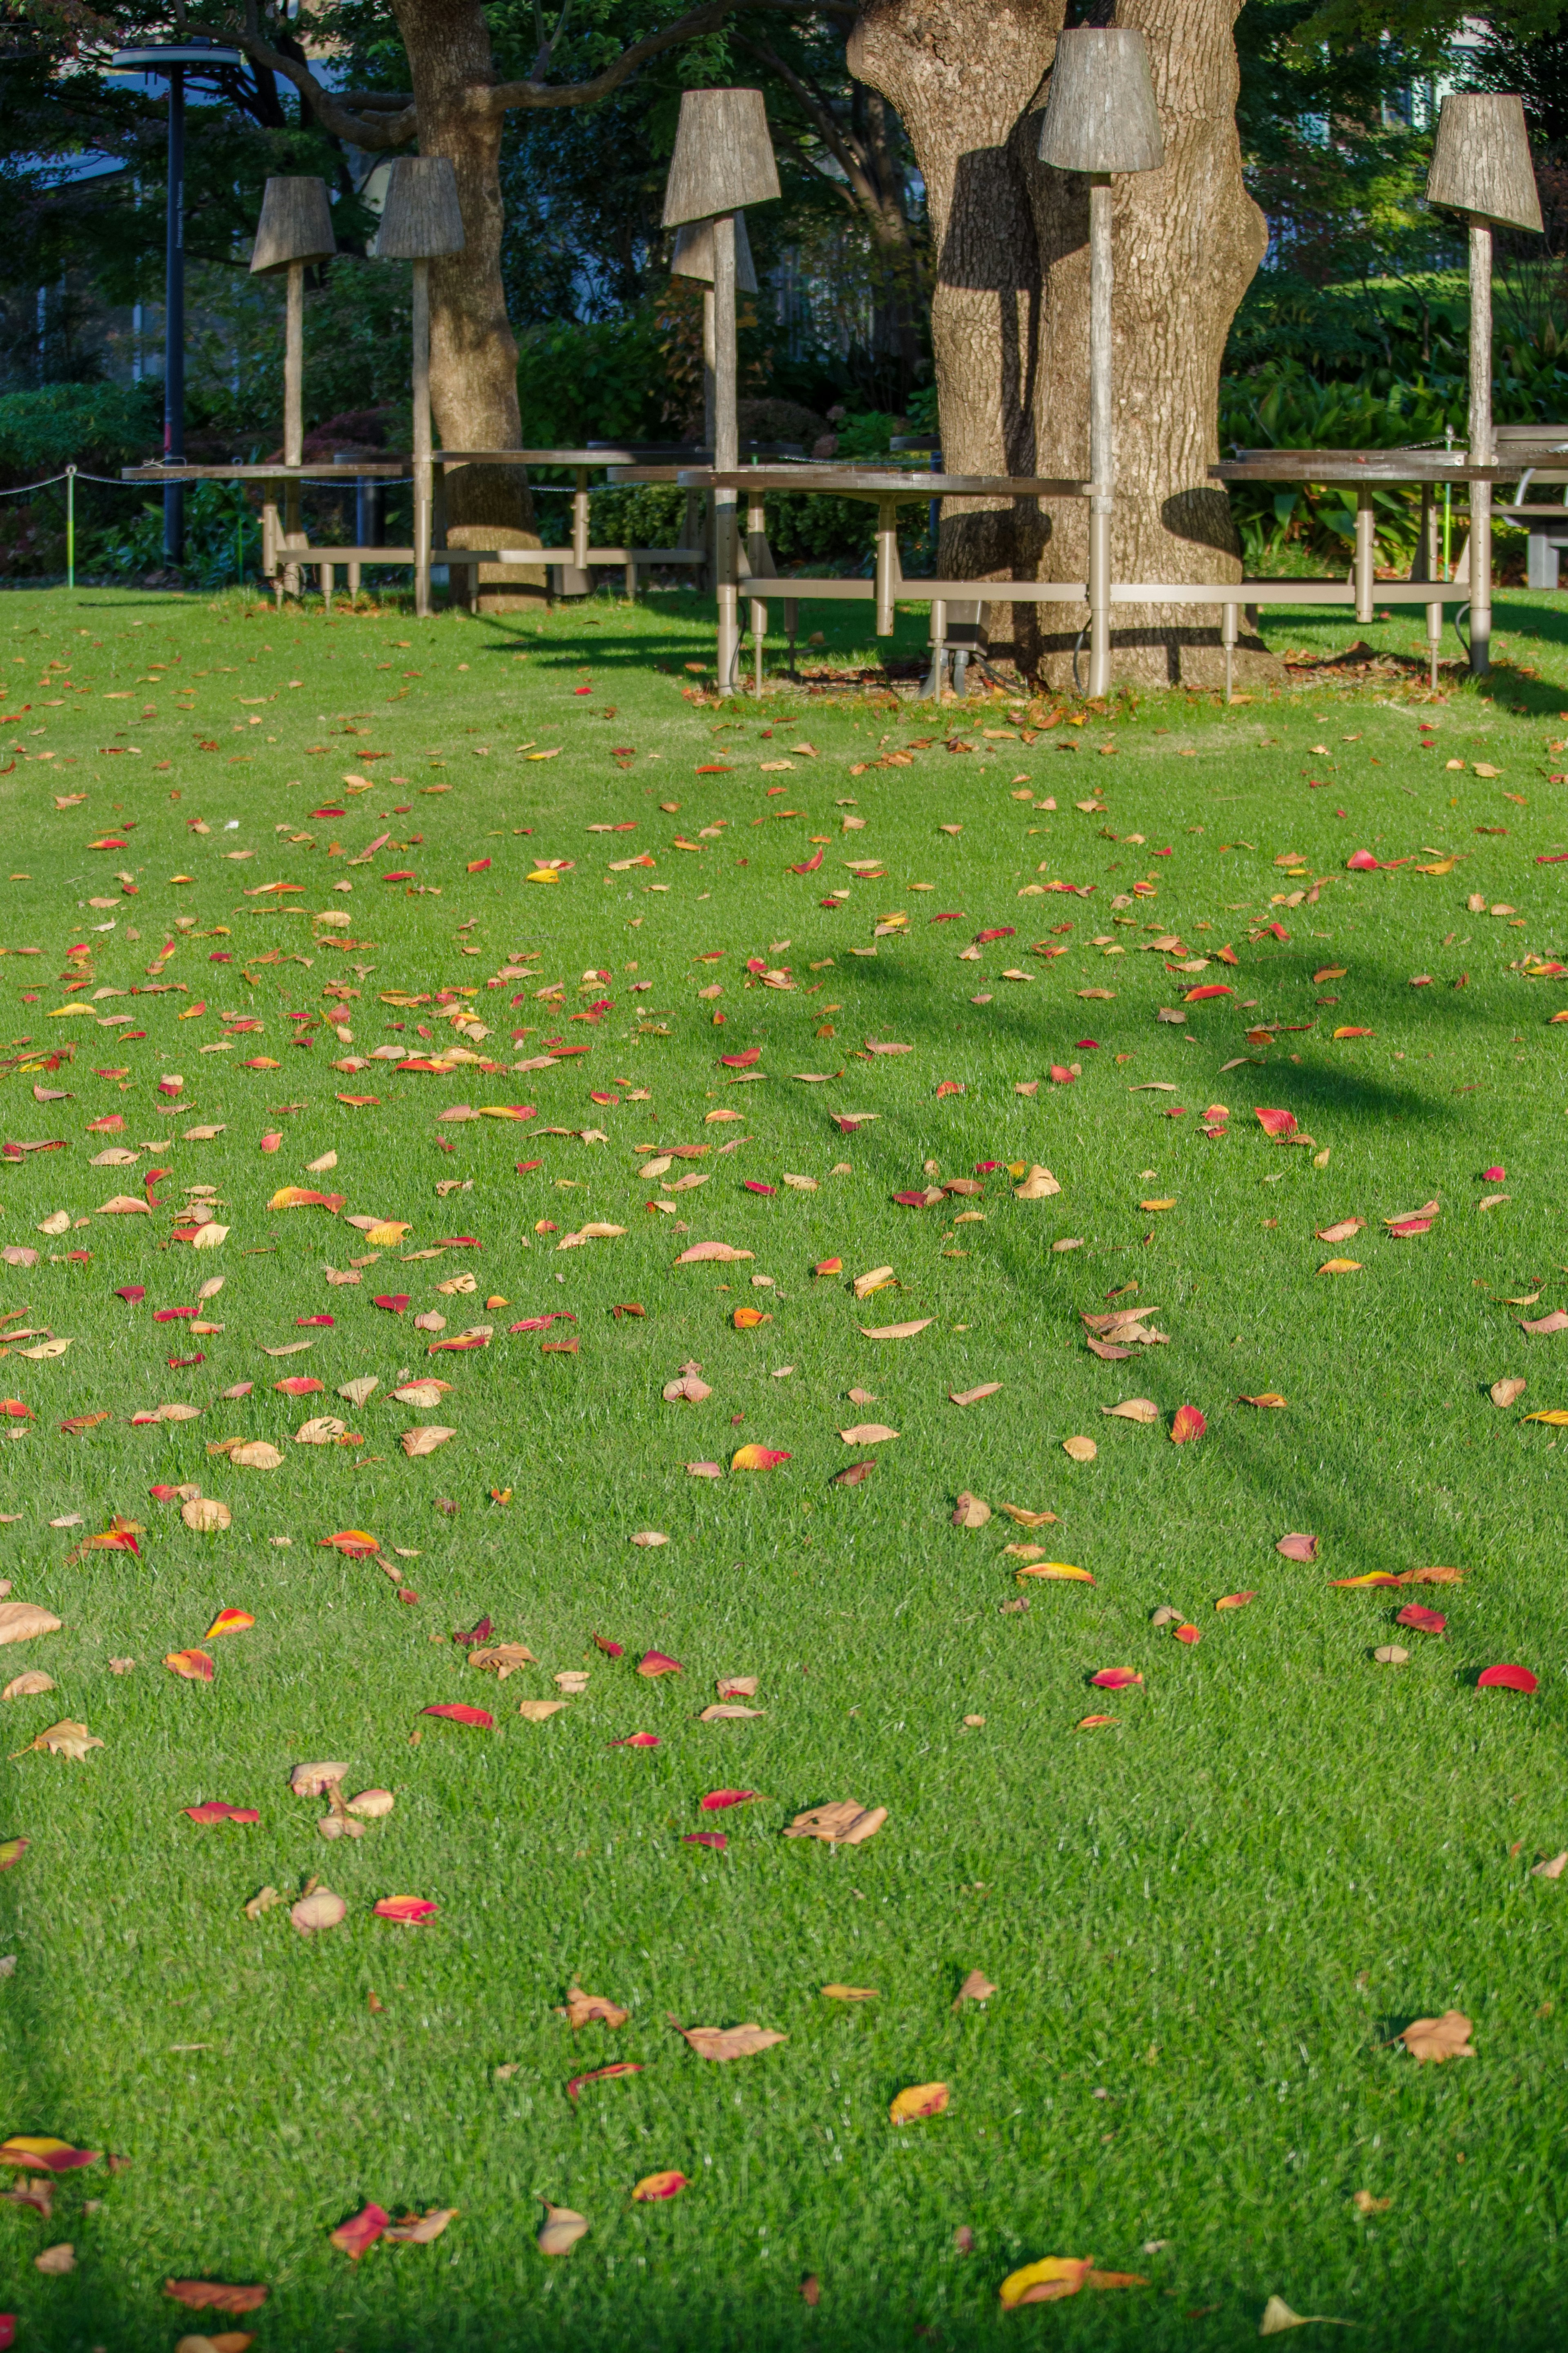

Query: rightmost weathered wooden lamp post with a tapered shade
1427;92;1542;675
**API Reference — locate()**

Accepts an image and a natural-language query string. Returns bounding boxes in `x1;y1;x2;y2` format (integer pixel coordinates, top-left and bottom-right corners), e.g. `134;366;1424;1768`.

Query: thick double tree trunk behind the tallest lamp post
849;0;1267;685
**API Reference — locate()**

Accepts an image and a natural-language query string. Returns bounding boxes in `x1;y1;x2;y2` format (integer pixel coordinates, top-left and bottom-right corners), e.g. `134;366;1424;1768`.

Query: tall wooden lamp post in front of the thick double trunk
1039;26;1166;696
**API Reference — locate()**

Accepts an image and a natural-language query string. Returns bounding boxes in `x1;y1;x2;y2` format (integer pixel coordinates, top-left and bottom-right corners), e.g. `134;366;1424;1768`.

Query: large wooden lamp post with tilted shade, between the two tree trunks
665;89;783;694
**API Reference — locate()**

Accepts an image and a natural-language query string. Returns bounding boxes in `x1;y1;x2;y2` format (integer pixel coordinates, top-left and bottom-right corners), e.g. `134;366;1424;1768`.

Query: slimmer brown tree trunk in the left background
395;0;546;612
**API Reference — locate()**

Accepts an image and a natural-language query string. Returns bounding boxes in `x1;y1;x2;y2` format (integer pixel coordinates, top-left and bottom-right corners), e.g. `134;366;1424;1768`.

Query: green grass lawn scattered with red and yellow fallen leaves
0;574;1568;2353
